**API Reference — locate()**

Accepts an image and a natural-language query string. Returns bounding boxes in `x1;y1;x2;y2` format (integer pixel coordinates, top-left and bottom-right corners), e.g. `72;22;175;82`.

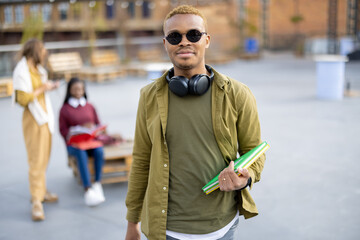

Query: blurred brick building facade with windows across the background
0;0;360;75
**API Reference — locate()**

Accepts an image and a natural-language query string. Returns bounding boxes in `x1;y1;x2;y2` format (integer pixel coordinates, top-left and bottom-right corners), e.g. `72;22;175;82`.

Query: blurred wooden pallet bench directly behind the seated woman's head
48;52;83;82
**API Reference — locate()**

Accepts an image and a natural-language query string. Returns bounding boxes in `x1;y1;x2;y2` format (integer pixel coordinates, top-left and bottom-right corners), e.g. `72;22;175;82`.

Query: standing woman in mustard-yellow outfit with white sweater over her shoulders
13;39;59;221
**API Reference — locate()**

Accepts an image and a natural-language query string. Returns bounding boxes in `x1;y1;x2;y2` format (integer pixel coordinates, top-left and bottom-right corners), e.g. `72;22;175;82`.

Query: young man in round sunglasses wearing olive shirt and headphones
126;5;265;240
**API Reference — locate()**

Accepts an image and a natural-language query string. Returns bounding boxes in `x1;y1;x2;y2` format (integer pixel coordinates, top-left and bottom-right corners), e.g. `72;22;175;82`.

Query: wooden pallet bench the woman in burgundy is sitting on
68;141;133;184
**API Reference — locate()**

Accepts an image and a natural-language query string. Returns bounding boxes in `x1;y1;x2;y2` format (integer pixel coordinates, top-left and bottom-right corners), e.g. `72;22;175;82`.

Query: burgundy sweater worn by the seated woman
59;103;100;142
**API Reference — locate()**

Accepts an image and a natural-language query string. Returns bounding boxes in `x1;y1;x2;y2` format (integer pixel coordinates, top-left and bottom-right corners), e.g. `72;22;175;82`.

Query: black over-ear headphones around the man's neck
166;65;214;97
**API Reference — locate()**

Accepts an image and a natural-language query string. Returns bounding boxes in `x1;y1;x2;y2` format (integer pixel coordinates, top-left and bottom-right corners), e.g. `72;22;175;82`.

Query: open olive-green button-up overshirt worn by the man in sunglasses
126;69;265;240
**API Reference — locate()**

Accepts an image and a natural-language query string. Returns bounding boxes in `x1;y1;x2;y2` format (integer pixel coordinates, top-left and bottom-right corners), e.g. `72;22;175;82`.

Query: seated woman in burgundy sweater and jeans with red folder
59;78;105;206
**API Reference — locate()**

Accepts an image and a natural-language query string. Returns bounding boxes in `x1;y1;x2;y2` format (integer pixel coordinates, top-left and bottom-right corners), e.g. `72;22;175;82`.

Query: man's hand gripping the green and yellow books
219;161;250;192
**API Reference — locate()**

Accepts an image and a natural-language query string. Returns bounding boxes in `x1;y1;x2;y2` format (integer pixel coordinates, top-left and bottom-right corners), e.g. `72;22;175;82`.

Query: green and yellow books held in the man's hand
202;141;270;194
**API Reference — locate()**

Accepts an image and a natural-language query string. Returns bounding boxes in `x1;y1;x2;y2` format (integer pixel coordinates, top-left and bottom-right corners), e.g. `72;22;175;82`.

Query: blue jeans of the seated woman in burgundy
67;146;104;188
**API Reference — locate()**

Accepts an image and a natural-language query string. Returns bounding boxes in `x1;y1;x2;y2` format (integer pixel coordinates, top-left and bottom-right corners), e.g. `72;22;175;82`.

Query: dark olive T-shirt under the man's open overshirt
166;86;237;234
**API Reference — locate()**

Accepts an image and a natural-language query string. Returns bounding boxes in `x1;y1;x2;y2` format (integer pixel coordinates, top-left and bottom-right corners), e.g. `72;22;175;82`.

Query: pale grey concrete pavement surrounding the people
0;53;360;240
